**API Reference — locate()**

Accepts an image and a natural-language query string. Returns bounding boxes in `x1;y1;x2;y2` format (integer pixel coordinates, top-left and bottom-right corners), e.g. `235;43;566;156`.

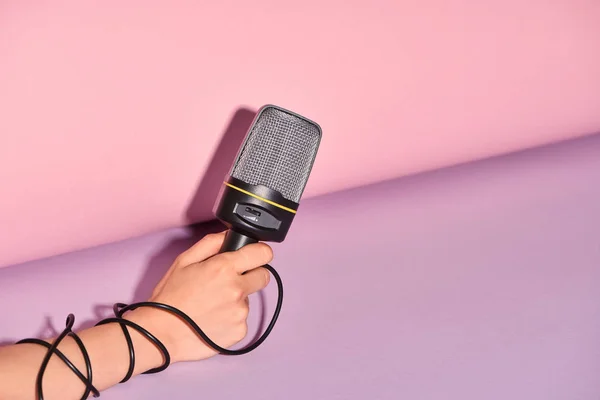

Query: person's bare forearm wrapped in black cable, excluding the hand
0;309;171;400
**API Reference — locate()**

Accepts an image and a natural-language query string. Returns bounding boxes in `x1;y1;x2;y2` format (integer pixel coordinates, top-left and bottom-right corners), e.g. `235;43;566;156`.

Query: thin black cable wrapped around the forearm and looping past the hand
17;264;283;400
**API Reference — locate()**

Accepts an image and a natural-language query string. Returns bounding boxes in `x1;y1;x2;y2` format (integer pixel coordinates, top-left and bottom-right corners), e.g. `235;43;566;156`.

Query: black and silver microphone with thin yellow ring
213;105;321;252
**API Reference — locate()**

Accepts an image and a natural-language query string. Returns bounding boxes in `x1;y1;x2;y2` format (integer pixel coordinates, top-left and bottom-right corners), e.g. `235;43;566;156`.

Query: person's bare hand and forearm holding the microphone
0;232;273;400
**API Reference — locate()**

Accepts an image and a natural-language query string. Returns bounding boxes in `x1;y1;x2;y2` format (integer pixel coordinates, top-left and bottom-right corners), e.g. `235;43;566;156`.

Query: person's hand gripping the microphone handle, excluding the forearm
130;232;273;362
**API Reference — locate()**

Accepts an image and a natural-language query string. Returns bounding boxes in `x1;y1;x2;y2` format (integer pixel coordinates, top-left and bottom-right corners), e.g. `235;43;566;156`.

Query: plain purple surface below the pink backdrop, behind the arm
0;136;600;400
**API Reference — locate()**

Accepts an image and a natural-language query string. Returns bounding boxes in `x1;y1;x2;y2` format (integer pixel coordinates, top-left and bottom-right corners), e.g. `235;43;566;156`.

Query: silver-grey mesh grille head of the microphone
231;106;321;203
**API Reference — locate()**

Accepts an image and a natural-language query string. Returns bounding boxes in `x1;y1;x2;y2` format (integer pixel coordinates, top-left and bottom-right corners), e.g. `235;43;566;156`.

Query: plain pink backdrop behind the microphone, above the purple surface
0;0;600;265
